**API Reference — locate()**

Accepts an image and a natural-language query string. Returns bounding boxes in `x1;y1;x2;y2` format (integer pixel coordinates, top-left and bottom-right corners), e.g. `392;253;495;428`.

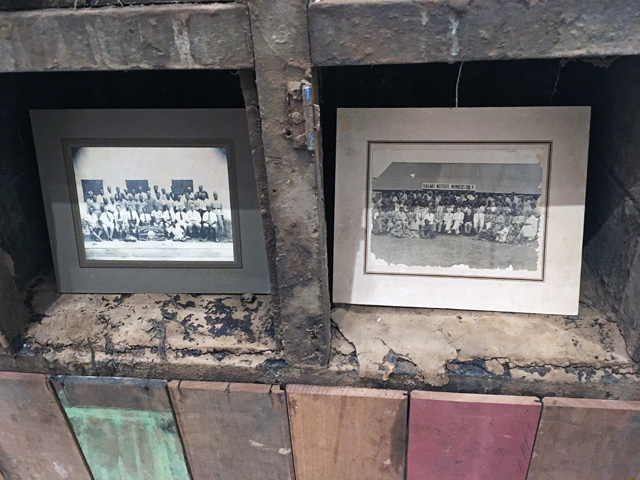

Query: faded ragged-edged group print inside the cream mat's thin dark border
365;143;549;280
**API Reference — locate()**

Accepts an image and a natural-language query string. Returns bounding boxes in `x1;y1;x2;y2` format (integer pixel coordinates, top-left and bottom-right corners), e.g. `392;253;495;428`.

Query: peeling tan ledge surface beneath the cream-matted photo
331;269;640;387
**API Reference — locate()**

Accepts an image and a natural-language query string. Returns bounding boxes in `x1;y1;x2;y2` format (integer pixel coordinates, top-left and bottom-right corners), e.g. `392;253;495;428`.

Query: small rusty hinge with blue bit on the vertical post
287;80;320;151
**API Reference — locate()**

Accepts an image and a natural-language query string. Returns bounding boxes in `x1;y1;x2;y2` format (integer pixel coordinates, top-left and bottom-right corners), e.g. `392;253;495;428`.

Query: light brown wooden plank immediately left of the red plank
287;385;408;480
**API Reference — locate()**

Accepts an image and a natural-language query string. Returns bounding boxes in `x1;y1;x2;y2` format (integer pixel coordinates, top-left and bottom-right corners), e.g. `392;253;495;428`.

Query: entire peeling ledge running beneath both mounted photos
0;268;640;400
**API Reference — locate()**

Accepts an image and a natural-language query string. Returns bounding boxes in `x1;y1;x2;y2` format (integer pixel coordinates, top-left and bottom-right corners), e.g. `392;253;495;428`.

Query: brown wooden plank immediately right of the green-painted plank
169;381;294;480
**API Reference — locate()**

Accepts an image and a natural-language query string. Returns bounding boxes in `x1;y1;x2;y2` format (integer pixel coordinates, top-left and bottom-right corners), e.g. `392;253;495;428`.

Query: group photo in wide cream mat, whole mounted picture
333;107;589;314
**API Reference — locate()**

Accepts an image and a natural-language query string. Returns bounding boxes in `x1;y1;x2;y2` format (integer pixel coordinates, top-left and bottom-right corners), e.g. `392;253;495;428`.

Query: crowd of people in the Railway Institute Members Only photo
372;192;540;243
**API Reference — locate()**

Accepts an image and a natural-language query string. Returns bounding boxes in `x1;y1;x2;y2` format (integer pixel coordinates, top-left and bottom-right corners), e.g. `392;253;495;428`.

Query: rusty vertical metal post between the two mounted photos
249;0;329;365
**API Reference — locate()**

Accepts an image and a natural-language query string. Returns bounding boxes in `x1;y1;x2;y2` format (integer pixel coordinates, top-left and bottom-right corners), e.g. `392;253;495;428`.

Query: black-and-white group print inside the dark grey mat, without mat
73;147;234;262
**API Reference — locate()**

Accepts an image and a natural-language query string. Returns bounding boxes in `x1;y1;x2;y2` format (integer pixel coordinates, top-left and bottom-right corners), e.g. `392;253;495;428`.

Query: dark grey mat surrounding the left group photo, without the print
31;109;270;294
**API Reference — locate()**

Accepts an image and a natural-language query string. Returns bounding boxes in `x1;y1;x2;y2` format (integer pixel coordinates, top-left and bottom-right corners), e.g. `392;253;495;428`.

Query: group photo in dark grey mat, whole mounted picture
31;109;269;293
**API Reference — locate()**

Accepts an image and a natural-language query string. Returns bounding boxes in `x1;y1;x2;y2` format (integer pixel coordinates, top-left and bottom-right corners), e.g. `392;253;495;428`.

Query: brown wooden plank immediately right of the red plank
527;398;640;480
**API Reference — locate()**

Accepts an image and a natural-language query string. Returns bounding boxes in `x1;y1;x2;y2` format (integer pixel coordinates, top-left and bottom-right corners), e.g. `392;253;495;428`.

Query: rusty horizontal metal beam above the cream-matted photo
309;0;640;66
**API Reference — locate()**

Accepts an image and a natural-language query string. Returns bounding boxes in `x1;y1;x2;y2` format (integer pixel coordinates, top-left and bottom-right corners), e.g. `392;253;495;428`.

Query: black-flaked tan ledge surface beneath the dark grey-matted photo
25;274;279;376
